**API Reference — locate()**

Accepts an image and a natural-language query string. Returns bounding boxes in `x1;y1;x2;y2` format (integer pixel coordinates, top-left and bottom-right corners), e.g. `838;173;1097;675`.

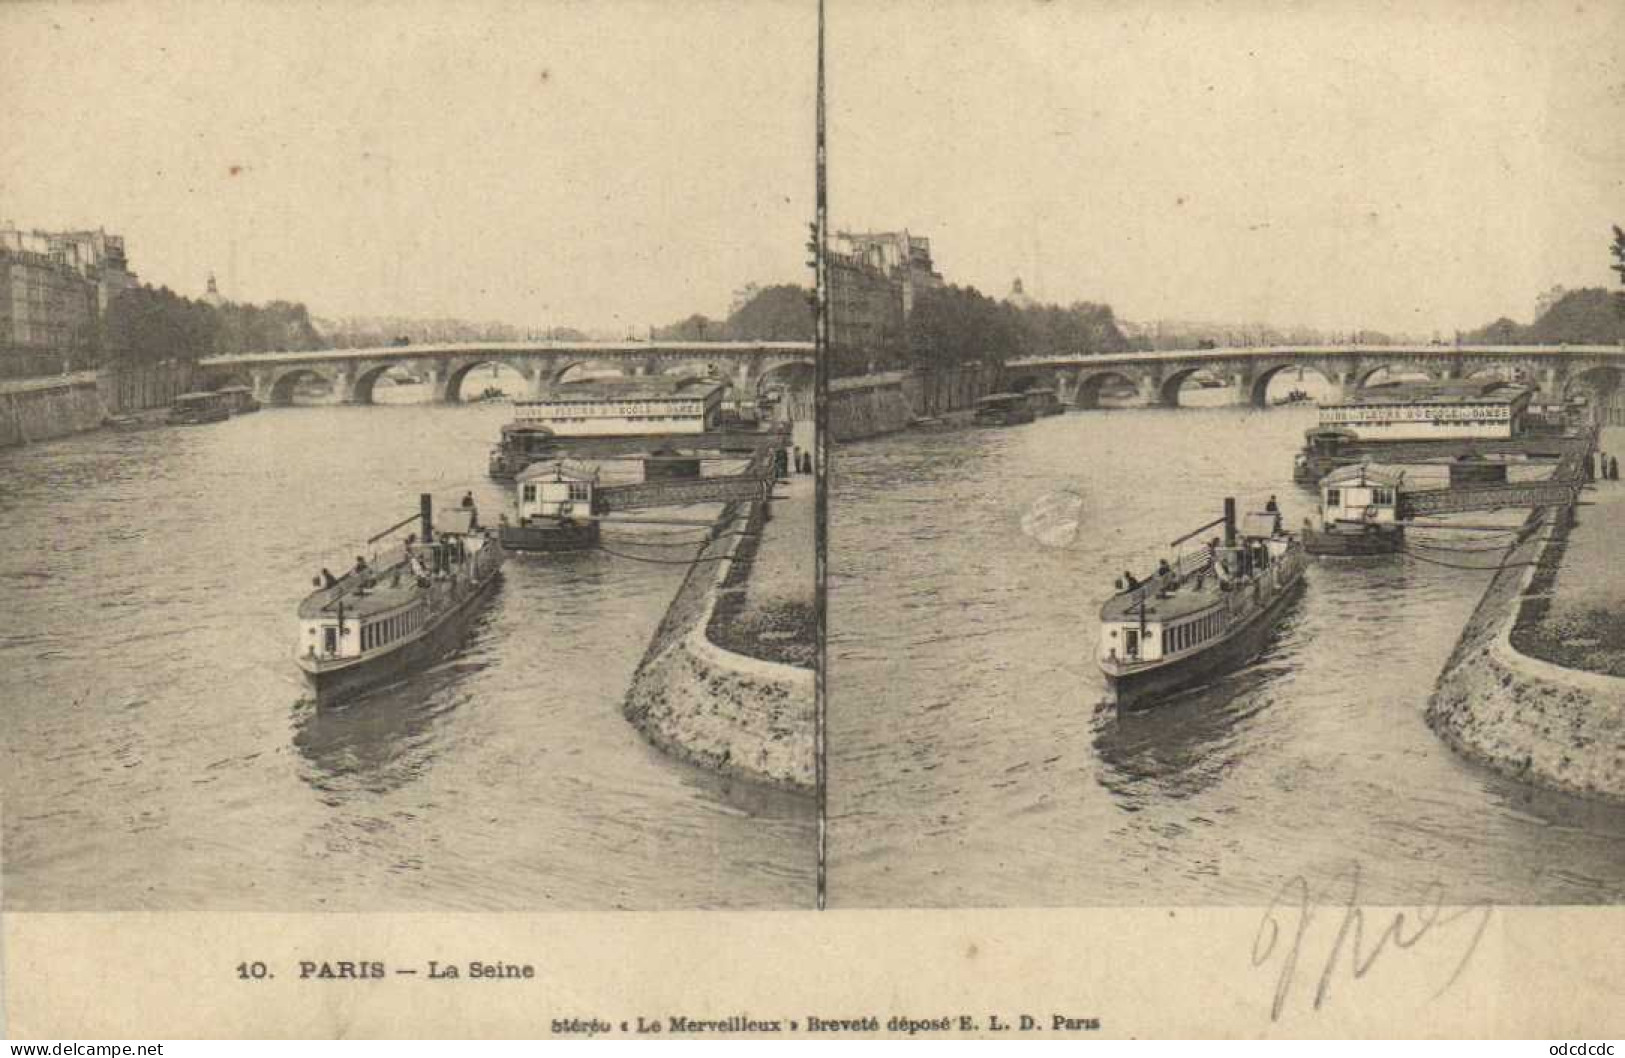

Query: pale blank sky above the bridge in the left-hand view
0;0;817;333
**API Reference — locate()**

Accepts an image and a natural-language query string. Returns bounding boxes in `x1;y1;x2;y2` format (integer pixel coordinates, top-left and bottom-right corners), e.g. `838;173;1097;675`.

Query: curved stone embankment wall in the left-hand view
622;501;816;793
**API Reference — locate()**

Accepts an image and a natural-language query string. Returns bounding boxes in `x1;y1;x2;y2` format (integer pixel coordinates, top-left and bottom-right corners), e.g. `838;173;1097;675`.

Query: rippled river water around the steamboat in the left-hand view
0;391;816;910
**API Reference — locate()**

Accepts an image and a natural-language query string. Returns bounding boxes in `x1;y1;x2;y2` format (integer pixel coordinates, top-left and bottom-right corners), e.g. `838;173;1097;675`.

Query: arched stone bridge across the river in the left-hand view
198;341;814;405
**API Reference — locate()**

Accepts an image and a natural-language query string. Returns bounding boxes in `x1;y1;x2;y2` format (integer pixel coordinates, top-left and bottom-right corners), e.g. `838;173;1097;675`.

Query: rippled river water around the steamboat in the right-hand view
827;408;1625;907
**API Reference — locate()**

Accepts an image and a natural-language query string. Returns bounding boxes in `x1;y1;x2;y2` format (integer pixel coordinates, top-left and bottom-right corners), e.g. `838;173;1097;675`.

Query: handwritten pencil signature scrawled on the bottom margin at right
1253;863;1495;1021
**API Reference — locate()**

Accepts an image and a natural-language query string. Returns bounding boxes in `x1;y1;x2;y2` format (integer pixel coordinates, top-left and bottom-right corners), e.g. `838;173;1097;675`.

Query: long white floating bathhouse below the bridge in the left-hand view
514;375;726;437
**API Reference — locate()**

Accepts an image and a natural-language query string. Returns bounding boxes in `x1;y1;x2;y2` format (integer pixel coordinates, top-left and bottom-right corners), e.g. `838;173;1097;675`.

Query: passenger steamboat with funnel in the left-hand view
297;494;504;705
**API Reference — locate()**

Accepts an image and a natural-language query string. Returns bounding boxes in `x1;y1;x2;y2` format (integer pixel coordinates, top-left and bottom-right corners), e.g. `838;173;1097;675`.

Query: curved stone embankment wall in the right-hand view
1427;509;1625;801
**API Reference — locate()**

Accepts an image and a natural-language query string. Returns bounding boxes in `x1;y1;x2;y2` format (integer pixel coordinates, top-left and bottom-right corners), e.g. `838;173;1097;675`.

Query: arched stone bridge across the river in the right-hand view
1004;345;1625;408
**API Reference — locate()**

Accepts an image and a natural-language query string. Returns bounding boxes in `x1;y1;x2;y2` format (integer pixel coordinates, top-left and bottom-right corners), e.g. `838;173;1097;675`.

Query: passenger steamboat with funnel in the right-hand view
1097;499;1307;709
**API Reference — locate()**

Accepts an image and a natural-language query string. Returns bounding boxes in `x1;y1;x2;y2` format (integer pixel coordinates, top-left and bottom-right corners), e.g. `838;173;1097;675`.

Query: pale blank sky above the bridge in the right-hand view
829;0;1625;335
